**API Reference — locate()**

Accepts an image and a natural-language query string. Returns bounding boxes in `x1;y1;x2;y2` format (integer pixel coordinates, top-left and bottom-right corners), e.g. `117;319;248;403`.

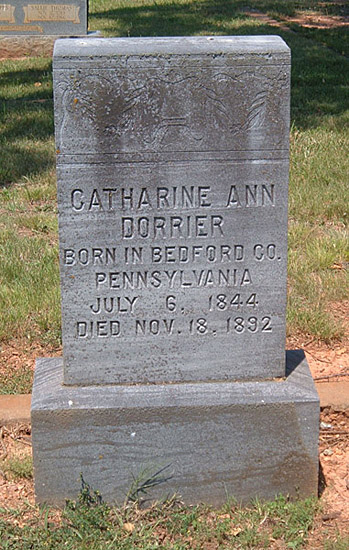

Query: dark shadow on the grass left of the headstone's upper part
0;61;54;187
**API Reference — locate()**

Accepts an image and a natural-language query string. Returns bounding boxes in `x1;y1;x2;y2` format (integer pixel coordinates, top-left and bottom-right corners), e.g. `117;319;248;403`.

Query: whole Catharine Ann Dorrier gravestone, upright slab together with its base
32;37;319;504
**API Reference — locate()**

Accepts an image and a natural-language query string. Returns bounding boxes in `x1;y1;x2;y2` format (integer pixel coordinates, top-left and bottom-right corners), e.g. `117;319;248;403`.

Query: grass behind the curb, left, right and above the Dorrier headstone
0;0;349;392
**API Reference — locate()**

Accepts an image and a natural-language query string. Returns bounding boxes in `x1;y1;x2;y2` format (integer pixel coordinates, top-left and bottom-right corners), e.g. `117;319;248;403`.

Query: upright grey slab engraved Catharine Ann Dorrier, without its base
54;36;290;385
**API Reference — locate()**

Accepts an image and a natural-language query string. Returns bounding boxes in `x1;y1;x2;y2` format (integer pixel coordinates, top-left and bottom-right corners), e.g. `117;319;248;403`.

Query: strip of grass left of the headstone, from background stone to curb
0;59;60;350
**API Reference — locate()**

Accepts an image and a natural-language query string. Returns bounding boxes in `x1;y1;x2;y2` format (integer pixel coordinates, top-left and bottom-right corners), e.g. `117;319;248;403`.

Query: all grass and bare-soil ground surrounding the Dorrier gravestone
0;0;349;550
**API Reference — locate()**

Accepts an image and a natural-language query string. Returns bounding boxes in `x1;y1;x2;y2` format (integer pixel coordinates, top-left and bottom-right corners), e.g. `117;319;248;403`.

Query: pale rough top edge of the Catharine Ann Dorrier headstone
54;35;290;64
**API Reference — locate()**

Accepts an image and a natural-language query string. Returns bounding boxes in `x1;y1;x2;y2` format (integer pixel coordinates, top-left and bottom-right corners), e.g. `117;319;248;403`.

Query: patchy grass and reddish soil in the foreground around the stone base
0;408;349;550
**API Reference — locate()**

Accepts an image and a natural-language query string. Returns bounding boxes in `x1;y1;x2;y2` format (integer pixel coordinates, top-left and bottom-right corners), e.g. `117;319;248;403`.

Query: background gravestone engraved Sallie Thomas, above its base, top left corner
0;0;87;36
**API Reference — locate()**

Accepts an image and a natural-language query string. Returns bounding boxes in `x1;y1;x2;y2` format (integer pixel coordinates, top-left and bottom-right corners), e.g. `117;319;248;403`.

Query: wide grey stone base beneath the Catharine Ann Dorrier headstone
32;351;319;505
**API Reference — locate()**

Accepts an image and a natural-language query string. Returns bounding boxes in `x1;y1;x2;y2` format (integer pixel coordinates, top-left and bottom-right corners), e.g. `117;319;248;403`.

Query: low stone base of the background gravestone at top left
0;31;102;59
